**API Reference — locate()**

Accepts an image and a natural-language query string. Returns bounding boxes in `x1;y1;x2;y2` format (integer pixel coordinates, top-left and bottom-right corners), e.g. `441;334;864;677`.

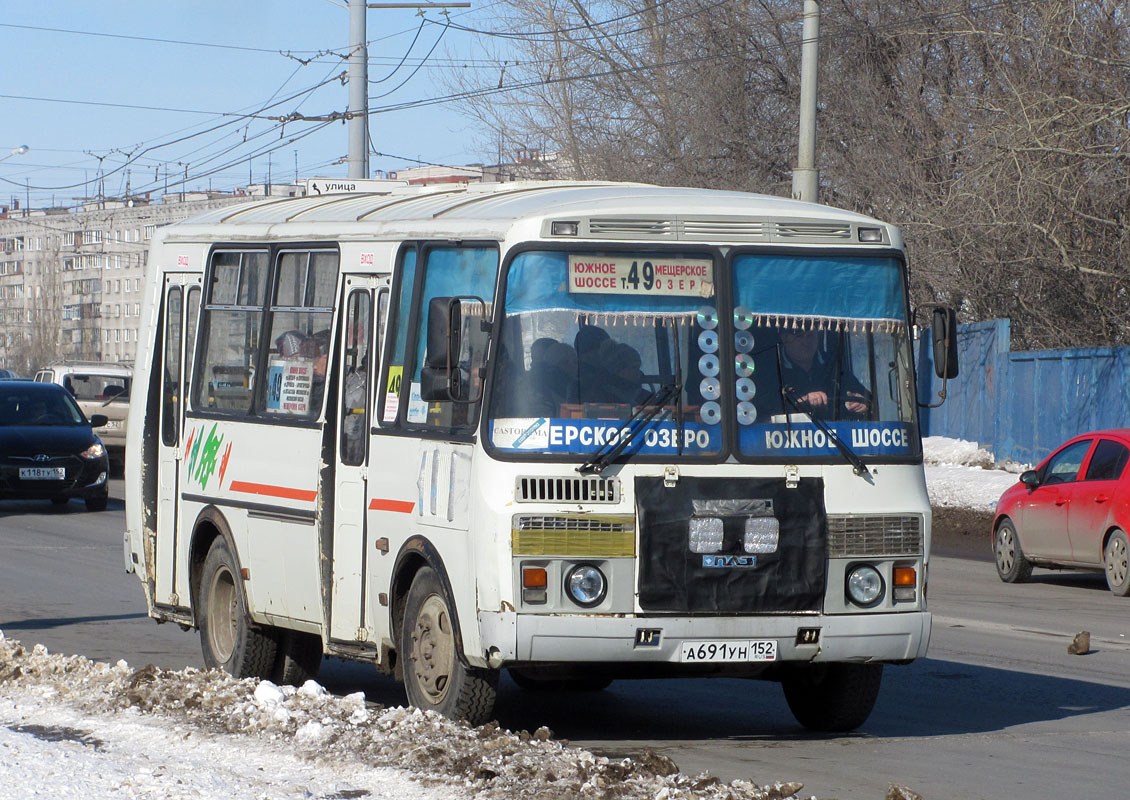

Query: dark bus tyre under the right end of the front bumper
781;663;883;733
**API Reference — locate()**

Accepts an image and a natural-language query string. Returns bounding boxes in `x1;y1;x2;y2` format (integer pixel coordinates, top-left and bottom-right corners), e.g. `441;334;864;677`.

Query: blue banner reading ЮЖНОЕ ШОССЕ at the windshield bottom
740;423;915;455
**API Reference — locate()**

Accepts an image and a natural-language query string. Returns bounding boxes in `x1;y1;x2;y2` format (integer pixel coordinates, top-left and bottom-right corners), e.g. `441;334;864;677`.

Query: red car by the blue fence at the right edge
992;429;1130;597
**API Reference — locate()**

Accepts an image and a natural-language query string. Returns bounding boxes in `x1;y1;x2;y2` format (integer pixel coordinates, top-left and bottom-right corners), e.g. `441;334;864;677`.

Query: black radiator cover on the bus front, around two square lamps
635;478;827;614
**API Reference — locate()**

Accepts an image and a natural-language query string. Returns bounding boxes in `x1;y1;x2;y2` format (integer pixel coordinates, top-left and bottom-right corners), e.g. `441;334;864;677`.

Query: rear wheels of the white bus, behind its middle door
198;537;278;678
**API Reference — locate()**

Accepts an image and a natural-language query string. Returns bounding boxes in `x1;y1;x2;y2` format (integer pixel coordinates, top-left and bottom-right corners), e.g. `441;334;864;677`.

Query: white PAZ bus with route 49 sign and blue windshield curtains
124;183;956;730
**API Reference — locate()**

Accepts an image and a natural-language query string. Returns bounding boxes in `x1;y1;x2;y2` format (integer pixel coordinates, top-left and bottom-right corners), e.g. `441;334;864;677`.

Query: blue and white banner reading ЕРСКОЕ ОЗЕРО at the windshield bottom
490;417;721;455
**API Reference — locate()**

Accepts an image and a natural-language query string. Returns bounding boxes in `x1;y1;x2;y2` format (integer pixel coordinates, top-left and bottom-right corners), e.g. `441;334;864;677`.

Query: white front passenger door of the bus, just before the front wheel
330;276;388;642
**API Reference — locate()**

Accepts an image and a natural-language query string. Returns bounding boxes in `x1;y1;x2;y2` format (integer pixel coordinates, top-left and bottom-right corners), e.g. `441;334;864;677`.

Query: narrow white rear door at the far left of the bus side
154;273;200;607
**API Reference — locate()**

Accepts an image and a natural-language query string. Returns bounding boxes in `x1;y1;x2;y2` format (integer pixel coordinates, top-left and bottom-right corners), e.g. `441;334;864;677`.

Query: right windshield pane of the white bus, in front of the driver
732;254;919;459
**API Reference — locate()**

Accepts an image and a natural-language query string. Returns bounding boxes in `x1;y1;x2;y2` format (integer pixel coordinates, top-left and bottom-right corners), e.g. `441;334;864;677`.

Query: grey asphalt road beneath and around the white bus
0;481;1130;800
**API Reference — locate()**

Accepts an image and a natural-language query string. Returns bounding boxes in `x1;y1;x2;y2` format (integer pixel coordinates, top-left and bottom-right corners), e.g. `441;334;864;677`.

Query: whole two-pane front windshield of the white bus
487;251;919;462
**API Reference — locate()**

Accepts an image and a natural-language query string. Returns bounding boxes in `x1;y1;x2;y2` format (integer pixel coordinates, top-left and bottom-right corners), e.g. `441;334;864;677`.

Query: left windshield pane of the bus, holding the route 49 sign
488;251;722;456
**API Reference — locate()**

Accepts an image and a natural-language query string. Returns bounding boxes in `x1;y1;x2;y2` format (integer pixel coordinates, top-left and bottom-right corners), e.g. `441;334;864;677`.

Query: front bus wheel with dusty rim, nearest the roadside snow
400;567;498;725
